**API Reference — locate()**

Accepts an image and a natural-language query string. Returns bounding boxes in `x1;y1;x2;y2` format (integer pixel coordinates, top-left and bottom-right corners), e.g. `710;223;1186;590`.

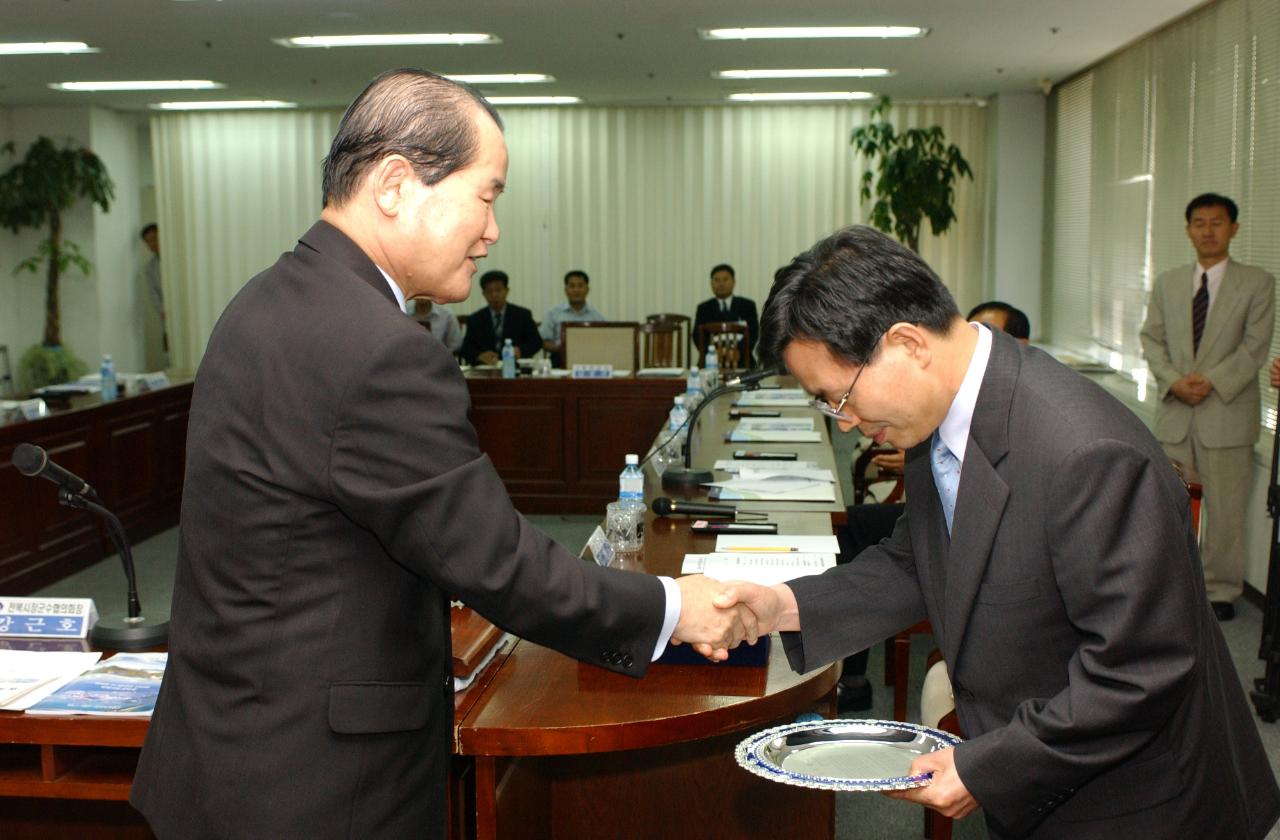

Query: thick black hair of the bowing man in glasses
760;225;960;366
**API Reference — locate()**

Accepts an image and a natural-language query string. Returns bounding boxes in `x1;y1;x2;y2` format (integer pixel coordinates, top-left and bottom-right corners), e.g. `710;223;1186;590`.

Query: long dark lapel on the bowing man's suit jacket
938;330;1021;663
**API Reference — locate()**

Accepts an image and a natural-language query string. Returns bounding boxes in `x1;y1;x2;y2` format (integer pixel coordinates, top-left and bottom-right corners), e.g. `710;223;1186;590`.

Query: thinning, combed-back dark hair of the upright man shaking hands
323;68;502;207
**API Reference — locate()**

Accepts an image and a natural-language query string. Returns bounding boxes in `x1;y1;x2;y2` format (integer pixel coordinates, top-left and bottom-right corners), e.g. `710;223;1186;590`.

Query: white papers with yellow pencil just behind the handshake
681;534;840;586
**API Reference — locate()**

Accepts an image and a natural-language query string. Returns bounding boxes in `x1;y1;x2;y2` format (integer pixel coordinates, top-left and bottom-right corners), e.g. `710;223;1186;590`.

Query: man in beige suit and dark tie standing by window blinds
1142;193;1275;621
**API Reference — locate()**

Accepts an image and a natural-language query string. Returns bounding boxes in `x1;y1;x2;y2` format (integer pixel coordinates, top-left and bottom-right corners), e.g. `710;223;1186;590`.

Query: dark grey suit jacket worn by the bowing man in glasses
783;332;1280;840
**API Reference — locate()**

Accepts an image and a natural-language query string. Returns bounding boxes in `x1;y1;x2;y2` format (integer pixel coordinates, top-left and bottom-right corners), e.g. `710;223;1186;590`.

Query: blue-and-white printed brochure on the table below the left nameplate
27;653;169;717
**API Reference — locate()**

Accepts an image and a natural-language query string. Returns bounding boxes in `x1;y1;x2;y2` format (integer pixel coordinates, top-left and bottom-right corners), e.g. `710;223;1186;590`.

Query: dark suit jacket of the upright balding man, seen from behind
131;223;664;837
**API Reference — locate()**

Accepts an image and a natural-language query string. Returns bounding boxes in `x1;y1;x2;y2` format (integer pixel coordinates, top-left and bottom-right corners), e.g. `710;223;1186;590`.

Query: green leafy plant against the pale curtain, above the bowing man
850;96;973;251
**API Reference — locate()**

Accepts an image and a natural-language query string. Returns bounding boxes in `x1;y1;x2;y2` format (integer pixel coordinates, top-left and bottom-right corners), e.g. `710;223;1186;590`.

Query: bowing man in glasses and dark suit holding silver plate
721;228;1280;840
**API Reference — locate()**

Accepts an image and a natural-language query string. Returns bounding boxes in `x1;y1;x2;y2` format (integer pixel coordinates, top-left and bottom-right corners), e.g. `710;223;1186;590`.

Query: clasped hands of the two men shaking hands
671;575;800;662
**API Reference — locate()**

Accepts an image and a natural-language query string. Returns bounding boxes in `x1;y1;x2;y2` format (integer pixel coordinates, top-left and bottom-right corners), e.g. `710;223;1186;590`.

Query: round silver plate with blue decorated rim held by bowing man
733;720;960;790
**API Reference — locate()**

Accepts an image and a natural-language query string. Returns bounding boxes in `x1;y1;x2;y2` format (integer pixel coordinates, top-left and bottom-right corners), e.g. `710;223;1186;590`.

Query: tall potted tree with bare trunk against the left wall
0;137;114;389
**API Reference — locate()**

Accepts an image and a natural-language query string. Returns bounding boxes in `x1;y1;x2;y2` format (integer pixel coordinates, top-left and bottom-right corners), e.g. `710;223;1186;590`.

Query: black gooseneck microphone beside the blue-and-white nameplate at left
10;443;169;650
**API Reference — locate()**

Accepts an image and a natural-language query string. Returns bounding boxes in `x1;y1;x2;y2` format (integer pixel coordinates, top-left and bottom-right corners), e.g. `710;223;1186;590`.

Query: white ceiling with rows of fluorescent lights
0;0;1203;109
